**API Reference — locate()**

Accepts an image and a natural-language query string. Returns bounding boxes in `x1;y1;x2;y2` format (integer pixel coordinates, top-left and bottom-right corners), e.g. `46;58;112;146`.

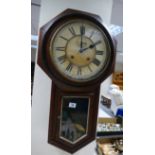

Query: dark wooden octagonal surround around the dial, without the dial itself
38;9;115;89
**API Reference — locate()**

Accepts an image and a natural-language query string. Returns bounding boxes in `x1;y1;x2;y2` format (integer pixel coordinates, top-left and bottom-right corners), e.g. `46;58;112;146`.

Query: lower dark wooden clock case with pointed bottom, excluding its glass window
48;82;100;153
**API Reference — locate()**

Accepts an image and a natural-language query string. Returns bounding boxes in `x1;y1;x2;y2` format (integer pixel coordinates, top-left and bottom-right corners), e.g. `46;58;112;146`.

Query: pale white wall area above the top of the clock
40;0;112;26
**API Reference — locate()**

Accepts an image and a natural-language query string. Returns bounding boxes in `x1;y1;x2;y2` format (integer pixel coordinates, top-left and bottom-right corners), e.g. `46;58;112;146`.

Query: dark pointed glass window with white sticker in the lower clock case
60;96;89;143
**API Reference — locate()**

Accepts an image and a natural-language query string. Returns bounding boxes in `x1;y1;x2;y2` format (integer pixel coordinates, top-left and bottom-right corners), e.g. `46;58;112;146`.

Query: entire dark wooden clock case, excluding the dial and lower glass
37;9;115;153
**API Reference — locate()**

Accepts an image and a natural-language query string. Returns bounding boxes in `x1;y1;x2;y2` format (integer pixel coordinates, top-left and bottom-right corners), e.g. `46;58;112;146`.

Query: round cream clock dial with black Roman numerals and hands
50;19;110;81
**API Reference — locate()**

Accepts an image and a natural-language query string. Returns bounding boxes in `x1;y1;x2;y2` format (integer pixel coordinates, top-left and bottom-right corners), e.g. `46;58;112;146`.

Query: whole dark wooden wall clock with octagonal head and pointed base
38;9;115;153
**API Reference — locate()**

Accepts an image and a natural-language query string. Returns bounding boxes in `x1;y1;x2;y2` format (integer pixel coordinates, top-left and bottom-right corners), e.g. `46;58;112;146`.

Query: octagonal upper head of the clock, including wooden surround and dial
38;9;115;87
